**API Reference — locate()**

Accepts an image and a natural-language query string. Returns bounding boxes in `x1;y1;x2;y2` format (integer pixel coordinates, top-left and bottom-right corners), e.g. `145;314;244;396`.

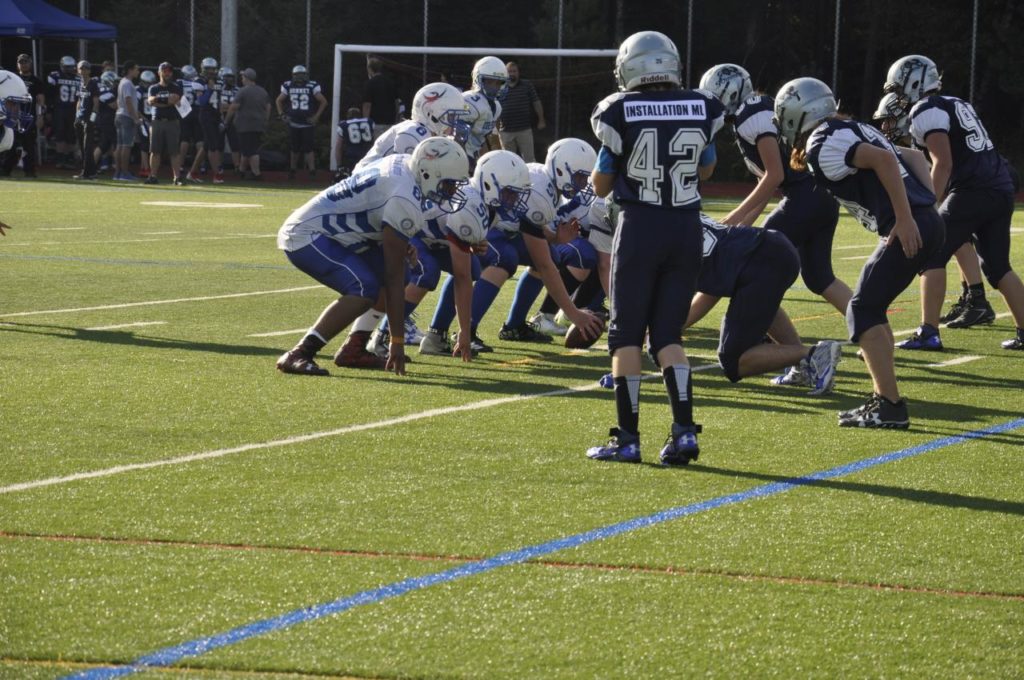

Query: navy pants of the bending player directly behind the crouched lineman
763;180;839;295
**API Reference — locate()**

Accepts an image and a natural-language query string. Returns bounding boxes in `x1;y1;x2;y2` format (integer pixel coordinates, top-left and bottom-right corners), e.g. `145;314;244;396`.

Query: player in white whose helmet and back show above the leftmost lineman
353;83;469;171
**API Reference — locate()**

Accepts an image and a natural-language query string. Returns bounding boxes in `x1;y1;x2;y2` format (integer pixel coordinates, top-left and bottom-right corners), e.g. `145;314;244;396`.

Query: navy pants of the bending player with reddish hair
846;206;945;342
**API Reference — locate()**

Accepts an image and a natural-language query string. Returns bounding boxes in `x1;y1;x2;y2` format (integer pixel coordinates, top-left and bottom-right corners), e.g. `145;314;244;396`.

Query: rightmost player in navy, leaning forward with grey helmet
885;54;1024;349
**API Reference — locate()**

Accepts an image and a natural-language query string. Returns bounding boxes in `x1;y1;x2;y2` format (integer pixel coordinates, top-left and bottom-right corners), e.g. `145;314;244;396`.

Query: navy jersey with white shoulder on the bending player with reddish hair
807;118;935;237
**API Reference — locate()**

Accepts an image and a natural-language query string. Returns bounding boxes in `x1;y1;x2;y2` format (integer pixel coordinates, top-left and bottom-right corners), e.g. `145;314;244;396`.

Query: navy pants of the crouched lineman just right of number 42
718;231;800;382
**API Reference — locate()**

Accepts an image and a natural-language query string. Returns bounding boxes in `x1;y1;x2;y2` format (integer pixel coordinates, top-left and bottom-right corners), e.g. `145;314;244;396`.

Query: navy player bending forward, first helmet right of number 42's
700;63;852;385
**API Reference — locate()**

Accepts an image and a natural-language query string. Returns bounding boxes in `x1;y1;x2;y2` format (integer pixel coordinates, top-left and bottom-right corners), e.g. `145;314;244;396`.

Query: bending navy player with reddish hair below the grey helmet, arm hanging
775;78;945;429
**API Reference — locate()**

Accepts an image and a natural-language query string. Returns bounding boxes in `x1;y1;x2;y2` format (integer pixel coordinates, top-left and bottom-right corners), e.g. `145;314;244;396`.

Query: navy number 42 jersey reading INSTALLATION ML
591;90;725;211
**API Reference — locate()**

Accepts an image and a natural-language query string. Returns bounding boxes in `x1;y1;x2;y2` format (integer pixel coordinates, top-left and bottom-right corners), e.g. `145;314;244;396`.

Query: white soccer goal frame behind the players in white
331;44;618;171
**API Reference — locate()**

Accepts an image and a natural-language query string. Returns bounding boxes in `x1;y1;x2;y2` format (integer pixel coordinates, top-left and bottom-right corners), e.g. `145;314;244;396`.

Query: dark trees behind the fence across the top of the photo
0;0;1024;178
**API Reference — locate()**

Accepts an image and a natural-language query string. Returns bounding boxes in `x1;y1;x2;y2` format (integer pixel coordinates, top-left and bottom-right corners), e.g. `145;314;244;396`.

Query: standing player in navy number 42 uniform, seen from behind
587;31;725;465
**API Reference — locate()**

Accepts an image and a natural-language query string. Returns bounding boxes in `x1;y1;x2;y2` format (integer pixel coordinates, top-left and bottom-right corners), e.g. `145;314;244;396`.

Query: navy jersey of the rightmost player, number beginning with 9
910;94;1013;192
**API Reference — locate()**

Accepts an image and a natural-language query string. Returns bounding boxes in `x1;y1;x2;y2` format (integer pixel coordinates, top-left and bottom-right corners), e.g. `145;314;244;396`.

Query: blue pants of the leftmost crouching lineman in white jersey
285;236;384;301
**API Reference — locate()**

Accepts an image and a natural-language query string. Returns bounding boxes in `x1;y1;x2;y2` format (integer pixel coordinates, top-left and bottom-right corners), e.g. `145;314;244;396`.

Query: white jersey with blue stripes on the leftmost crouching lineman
278;154;424;251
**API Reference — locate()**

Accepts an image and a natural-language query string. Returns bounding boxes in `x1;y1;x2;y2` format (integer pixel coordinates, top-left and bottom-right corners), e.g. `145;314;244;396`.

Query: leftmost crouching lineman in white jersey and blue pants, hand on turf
278;137;469;376
